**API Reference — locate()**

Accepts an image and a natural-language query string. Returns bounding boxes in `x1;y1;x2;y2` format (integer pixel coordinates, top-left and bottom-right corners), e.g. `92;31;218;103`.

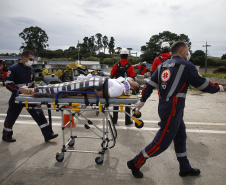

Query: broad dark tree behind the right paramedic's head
141;31;191;63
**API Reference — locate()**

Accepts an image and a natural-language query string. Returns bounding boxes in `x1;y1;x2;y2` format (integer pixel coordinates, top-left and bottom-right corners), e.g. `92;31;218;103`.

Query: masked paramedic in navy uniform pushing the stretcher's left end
2;51;58;142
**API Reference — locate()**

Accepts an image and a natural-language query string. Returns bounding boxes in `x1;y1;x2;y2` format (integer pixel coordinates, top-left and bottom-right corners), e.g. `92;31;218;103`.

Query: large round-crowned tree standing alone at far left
19;26;49;54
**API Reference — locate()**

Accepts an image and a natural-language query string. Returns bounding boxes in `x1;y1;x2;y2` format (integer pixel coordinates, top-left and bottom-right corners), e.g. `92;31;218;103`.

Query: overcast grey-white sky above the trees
0;0;226;57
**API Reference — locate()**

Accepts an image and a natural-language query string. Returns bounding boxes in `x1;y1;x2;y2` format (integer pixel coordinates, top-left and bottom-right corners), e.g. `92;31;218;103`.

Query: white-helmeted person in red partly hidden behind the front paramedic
151;42;171;75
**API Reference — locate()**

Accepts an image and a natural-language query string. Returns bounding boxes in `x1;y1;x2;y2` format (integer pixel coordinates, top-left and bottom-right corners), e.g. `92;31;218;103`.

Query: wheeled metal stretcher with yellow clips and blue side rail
16;91;144;164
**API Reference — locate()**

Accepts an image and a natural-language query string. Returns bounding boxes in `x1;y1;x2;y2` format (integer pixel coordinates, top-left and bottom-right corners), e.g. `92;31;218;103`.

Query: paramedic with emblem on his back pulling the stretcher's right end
127;41;223;178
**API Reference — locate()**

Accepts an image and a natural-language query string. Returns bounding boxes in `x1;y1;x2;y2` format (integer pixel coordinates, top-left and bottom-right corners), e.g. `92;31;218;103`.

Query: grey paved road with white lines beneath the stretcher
0;87;226;185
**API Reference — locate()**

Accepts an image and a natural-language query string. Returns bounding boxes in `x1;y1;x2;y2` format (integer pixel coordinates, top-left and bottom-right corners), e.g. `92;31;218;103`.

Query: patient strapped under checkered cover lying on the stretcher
19;76;139;98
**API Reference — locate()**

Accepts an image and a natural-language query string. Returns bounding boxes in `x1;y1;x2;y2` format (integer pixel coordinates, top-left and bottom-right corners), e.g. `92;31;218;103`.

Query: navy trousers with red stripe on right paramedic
133;106;191;172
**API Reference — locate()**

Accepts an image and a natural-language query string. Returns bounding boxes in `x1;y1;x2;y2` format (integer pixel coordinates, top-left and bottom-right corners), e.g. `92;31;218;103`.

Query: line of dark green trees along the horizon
0;26;226;66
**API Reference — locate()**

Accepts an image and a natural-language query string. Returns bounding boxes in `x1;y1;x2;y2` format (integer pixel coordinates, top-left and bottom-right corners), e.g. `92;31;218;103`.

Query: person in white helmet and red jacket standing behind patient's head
110;49;136;125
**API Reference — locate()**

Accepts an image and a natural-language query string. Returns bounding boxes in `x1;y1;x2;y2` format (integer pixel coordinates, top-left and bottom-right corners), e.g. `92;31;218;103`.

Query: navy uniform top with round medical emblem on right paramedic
141;56;220;109
